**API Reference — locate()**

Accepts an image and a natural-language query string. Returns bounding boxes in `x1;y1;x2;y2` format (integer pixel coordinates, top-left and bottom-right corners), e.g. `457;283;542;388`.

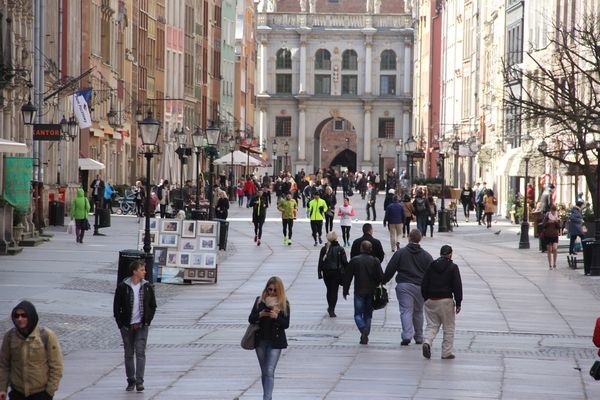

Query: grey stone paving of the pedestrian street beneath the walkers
0;192;600;400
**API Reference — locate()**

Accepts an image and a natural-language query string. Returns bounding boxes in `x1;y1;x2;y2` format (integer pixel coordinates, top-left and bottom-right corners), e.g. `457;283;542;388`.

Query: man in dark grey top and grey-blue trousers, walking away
383;229;433;346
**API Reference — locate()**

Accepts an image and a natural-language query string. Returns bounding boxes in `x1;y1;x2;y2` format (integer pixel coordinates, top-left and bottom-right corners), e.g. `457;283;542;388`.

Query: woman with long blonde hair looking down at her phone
248;276;290;400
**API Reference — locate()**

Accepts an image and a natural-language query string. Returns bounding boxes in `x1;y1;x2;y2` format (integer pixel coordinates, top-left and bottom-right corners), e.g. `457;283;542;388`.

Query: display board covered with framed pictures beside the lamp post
138;218;219;283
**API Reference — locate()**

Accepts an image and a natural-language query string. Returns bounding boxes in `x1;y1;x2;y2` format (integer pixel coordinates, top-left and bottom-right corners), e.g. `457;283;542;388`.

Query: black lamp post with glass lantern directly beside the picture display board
138;111;160;282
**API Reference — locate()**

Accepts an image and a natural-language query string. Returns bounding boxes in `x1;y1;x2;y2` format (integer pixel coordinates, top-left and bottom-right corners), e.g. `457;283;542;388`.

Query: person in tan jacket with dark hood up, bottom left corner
0;300;63;400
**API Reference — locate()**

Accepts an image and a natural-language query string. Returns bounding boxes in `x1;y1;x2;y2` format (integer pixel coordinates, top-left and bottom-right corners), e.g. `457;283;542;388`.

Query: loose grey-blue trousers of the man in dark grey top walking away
396;282;424;342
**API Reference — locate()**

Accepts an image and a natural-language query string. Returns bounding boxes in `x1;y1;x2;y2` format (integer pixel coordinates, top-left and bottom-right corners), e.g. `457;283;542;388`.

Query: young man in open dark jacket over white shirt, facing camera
113;260;156;392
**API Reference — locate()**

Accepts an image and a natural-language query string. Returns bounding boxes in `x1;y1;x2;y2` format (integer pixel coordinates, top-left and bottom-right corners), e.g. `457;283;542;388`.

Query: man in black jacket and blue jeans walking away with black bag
343;240;383;344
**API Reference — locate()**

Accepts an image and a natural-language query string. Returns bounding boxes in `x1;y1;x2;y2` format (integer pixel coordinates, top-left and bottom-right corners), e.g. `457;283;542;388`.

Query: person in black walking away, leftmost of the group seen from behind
317;231;348;318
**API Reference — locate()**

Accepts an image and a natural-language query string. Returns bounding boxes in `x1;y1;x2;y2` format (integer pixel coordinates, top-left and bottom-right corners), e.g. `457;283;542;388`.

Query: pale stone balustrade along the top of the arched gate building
258;13;413;29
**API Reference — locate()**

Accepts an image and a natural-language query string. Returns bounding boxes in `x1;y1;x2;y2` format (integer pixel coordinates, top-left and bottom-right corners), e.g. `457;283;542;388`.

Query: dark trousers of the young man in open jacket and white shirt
121;326;148;385
